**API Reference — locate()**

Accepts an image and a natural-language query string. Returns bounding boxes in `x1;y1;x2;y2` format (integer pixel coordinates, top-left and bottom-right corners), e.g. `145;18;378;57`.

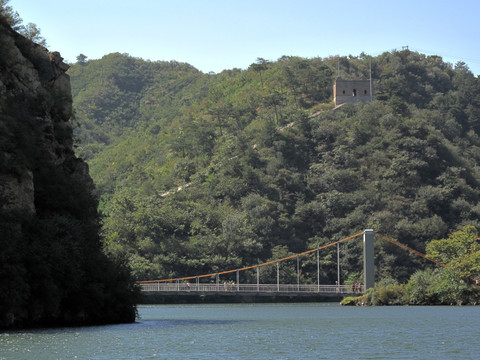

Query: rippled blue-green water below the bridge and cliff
0;304;480;360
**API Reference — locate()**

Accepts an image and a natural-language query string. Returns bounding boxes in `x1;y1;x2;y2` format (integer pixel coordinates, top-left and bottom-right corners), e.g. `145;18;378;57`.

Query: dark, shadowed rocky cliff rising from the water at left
0;17;135;328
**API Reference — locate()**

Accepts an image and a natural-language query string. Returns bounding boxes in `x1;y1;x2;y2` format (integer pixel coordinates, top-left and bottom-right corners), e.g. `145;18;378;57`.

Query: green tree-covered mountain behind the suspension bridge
69;50;480;283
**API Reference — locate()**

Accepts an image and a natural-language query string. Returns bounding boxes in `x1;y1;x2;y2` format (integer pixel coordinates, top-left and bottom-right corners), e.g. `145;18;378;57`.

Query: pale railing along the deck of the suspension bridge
139;282;364;294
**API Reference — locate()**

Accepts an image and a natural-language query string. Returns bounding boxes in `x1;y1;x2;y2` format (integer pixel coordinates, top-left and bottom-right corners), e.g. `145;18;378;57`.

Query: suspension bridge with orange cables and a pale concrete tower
137;230;443;298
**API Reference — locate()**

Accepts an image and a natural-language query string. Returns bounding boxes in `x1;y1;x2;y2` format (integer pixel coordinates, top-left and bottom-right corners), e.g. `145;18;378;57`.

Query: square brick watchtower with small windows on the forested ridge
333;78;373;106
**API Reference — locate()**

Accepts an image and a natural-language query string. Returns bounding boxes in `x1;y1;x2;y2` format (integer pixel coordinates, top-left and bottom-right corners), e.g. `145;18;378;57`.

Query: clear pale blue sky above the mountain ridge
9;0;480;75
